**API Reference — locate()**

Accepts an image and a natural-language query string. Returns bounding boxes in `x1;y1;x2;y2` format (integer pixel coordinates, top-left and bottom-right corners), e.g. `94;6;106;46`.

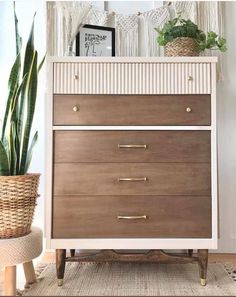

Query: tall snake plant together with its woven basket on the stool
0;6;44;238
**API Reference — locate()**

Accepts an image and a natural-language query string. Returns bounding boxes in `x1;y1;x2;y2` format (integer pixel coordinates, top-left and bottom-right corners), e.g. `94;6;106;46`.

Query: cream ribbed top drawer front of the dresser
53;62;211;94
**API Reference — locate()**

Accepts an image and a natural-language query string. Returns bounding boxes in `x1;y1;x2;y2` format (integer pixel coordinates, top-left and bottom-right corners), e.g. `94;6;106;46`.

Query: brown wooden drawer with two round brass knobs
54;95;211;126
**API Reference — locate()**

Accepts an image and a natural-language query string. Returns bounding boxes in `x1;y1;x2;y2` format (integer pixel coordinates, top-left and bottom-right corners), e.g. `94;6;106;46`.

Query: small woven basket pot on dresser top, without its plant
165;37;199;57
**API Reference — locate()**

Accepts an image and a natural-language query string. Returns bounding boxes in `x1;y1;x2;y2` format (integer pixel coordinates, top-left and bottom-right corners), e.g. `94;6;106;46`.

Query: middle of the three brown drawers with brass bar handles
54;163;211;196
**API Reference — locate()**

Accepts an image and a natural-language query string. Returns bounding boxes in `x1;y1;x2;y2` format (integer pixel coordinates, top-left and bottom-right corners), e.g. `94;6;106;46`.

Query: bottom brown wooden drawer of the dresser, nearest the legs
53;196;211;238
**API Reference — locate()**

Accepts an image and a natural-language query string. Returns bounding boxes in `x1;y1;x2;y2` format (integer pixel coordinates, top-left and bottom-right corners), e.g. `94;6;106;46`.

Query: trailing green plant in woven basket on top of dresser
155;15;227;56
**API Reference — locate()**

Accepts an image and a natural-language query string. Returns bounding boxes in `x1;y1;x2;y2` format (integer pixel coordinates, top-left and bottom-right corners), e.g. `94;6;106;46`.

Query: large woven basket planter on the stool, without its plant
0;174;40;238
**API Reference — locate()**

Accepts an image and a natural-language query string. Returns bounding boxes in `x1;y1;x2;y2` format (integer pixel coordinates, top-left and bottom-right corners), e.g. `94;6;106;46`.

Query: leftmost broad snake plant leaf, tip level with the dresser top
1;54;21;140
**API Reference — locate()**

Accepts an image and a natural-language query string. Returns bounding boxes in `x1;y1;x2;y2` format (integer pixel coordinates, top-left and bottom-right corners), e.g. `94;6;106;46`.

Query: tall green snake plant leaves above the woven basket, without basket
0;5;45;175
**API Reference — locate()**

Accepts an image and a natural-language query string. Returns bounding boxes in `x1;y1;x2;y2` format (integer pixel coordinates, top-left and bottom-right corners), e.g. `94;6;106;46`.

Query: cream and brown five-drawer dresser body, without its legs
46;57;217;284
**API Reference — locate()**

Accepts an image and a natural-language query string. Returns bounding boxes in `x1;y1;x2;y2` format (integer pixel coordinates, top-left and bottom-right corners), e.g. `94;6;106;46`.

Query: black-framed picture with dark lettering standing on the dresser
76;25;115;57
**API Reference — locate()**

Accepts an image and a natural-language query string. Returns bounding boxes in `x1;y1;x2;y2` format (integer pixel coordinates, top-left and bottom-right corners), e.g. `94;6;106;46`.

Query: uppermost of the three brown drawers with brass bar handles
54;131;211;163
